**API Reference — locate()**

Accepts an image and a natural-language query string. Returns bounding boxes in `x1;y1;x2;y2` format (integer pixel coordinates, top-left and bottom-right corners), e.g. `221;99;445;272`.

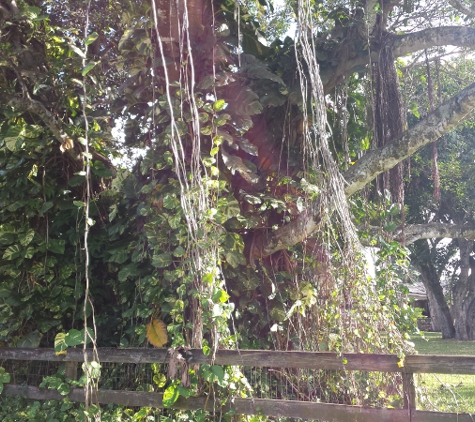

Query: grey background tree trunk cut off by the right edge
453;239;475;340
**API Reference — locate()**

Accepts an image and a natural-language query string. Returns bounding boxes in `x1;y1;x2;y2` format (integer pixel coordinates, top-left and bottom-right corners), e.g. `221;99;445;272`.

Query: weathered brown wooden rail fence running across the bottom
0;348;475;422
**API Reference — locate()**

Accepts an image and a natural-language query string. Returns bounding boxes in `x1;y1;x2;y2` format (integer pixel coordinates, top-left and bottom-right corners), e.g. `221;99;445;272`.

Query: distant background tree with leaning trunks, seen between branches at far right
398;51;473;339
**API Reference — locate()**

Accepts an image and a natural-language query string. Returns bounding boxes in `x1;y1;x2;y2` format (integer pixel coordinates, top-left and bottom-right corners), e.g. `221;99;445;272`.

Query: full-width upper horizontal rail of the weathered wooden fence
0;347;475;374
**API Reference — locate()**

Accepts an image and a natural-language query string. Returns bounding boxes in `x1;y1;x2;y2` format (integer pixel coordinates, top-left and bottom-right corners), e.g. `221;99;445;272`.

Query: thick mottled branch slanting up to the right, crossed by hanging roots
262;83;475;255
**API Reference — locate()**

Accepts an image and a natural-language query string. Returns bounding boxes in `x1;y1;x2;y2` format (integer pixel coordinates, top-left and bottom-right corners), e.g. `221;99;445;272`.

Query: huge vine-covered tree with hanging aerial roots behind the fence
0;0;475;418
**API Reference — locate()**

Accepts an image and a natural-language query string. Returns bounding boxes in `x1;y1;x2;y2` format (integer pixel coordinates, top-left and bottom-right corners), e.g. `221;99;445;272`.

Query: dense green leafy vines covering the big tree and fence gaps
0;0;472;420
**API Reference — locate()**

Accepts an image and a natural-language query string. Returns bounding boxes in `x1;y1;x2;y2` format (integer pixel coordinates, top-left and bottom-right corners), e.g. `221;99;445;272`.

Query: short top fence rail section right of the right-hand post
404;355;475;374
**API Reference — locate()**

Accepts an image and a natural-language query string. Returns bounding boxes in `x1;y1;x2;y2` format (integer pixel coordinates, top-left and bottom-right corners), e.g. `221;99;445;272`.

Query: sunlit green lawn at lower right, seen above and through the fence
411;333;475;413
